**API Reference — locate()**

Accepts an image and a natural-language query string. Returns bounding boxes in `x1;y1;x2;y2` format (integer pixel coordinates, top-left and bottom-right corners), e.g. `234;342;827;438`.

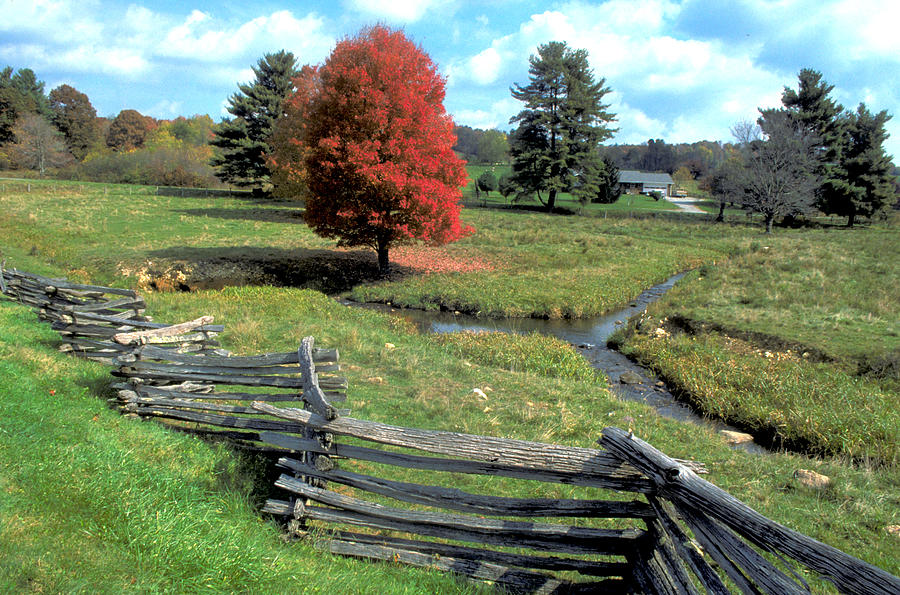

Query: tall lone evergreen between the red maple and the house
510;41;615;211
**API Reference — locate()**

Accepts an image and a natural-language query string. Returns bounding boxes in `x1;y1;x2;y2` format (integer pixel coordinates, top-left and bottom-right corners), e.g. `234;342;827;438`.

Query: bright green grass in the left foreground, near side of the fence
0;301;471;593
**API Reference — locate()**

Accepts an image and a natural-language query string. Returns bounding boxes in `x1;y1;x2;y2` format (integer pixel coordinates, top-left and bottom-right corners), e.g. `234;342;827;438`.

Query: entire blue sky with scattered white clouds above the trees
7;0;900;157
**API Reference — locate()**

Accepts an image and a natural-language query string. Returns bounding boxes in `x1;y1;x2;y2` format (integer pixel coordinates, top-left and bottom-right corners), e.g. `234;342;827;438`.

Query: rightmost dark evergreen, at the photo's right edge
833;103;897;227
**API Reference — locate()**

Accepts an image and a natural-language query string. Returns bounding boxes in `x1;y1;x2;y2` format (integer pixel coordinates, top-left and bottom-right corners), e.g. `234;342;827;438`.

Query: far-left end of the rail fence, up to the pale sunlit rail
0;267;226;363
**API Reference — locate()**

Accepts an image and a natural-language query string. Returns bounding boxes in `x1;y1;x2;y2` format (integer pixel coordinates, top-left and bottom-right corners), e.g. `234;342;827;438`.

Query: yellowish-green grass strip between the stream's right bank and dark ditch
624;327;900;466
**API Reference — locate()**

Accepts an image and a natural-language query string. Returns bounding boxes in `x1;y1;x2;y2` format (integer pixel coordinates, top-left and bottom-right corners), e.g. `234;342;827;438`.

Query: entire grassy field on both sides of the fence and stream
0;180;900;593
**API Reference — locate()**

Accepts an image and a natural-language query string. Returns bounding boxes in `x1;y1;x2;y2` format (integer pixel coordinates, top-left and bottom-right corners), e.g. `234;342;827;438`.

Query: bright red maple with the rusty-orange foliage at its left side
269;26;473;274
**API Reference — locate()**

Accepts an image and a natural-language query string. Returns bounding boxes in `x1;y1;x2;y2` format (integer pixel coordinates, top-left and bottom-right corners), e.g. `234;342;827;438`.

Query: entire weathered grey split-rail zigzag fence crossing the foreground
0;270;900;595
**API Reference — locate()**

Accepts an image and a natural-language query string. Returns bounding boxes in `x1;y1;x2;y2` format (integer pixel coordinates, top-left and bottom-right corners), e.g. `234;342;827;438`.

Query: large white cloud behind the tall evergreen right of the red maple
451;0;800;143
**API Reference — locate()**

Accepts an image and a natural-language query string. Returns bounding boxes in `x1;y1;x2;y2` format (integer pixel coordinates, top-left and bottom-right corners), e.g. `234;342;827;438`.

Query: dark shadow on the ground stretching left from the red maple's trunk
145;246;417;294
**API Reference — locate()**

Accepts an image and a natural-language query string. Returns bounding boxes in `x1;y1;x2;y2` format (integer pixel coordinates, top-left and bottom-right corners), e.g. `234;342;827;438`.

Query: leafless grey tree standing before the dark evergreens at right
732;109;821;233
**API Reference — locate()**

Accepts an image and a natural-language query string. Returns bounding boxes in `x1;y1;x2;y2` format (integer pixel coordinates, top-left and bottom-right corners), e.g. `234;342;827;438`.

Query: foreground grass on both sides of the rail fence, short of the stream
0;276;900;592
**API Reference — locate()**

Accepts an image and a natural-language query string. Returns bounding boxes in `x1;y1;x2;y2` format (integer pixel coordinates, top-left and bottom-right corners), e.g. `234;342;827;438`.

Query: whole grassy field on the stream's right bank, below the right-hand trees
623;227;900;465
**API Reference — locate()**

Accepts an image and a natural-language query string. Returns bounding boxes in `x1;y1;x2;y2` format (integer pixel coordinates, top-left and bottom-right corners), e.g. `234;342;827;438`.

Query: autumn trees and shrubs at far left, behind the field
0;66;218;186
